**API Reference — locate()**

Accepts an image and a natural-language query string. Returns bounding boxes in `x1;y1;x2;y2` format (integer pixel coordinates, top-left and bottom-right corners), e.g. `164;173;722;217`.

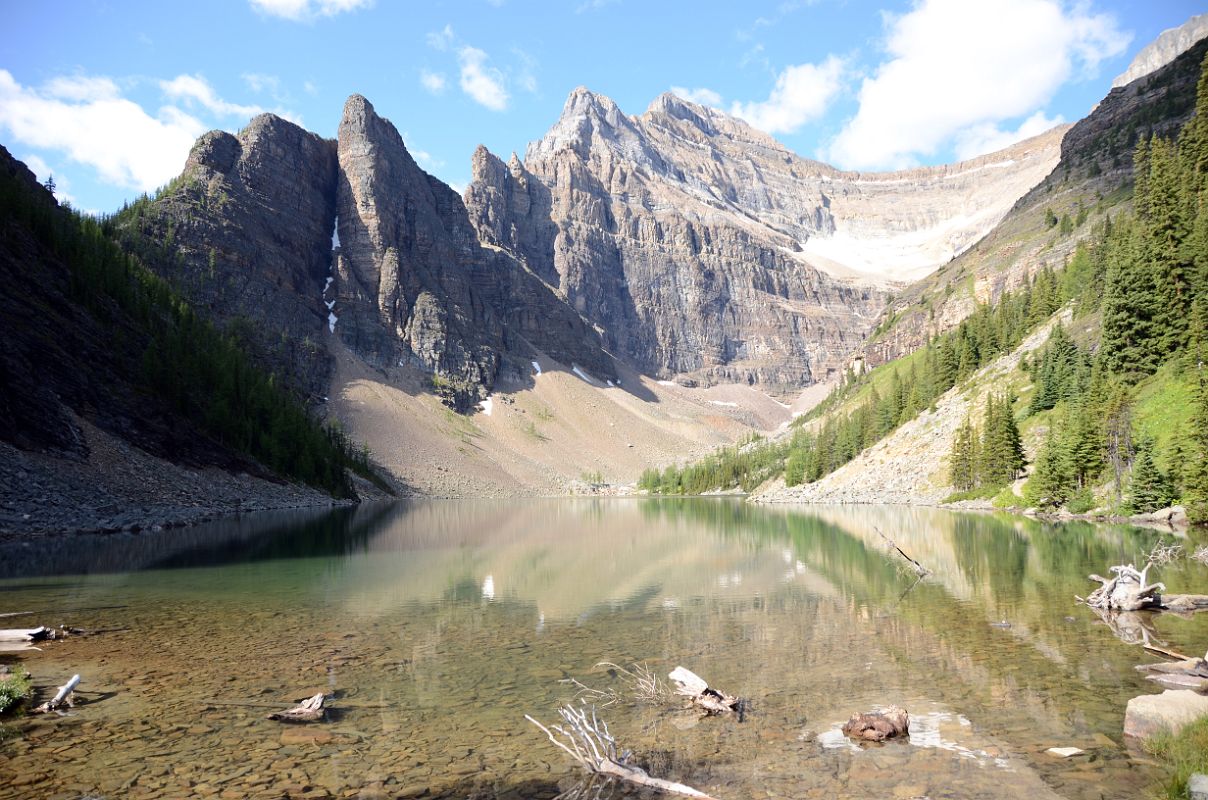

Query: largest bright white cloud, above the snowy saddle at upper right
824;0;1129;169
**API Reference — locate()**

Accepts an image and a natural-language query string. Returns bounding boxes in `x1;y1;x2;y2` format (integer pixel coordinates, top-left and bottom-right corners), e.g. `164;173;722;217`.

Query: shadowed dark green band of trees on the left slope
0;164;381;497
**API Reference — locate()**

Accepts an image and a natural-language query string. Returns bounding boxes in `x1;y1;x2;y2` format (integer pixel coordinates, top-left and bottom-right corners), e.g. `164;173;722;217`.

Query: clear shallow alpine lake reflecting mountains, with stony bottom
0;499;1208;800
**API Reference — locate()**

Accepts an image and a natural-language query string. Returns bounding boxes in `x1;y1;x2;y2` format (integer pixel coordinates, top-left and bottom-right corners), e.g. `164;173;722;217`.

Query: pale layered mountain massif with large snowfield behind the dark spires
466;88;1062;389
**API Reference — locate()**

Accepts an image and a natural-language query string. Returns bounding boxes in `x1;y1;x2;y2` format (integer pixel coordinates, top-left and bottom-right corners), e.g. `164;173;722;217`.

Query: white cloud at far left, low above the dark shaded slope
0;70;208;191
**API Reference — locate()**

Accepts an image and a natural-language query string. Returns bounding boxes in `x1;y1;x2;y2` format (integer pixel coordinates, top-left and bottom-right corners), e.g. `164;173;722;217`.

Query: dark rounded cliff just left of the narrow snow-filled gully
126;114;336;394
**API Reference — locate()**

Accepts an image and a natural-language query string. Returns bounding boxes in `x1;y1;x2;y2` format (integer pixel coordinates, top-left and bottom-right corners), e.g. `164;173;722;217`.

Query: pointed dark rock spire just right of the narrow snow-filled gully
332;95;615;407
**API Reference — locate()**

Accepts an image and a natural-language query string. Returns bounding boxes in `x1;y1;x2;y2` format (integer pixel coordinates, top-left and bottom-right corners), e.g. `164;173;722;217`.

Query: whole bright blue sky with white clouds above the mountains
0;0;1208;211
